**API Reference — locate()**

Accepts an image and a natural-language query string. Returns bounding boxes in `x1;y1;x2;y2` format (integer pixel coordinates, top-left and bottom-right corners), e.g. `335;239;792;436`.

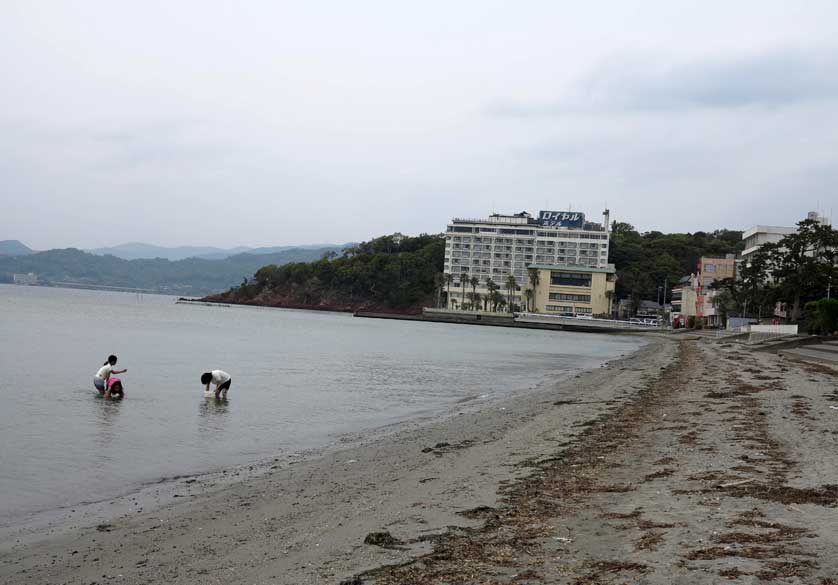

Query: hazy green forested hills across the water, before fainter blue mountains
0;247;341;296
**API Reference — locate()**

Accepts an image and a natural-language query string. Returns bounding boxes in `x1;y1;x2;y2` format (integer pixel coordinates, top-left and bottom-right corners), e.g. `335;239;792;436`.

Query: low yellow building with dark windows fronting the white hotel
527;264;617;316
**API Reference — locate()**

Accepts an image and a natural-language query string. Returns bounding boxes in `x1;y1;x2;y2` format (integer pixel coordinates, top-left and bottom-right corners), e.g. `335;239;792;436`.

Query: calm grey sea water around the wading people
0;285;640;522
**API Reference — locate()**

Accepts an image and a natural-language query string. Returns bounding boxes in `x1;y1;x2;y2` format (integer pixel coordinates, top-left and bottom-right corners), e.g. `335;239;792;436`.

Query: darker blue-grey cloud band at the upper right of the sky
490;49;838;117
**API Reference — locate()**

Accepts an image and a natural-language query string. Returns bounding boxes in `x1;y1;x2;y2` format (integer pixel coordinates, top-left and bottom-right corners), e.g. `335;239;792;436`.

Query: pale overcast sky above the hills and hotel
0;0;838;249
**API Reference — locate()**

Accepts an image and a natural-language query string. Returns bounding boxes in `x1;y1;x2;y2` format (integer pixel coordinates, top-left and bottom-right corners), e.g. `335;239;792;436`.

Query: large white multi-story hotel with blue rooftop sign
444;209;609;308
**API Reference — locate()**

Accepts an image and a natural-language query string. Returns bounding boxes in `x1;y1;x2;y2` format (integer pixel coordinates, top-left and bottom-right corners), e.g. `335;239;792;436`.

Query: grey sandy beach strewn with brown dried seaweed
0;339;838;585
